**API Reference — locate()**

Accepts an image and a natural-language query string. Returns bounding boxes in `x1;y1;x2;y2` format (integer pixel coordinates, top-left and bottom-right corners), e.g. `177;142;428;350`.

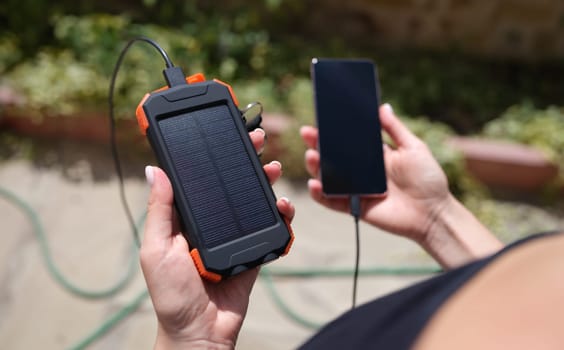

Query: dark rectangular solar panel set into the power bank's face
158;105;276;248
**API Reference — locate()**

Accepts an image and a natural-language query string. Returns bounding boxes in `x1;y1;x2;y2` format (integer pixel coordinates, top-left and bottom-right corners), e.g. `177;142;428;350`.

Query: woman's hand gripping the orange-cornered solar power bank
140;129;294;349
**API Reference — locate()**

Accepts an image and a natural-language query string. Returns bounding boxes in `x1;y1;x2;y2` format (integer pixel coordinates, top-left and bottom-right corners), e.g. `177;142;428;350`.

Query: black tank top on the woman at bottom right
300;232;554;350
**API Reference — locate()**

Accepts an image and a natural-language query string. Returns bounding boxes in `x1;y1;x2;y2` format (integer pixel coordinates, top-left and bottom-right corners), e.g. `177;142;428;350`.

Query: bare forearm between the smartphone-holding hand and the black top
419;195;503;269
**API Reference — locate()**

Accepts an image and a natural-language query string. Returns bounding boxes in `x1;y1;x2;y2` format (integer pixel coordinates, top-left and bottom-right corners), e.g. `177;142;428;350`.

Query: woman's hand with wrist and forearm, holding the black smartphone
300;104;502;267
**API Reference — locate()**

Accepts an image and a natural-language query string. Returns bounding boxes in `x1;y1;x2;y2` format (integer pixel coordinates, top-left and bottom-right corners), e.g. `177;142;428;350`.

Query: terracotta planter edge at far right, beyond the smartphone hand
449;137;558;191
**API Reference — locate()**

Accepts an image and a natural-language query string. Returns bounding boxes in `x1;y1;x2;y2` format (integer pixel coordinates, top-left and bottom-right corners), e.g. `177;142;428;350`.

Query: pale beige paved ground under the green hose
0;138;434;350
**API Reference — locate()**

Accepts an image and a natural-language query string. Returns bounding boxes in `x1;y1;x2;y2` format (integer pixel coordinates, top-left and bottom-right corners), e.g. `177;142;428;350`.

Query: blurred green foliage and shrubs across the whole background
0;0;564;237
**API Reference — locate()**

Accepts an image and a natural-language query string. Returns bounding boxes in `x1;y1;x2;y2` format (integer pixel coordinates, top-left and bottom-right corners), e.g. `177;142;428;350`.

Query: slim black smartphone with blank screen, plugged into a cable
311;58;387;196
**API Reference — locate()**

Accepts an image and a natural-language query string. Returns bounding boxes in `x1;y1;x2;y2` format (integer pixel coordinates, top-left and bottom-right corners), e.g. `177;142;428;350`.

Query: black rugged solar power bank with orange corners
136;74;293;282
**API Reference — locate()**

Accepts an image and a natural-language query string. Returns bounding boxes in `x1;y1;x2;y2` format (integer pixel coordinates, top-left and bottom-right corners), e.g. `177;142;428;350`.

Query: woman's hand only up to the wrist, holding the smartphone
300;104;450;241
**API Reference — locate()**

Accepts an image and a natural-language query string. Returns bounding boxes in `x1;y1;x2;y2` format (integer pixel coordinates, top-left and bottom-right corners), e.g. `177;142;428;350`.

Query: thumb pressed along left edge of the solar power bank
143;166;174;248
